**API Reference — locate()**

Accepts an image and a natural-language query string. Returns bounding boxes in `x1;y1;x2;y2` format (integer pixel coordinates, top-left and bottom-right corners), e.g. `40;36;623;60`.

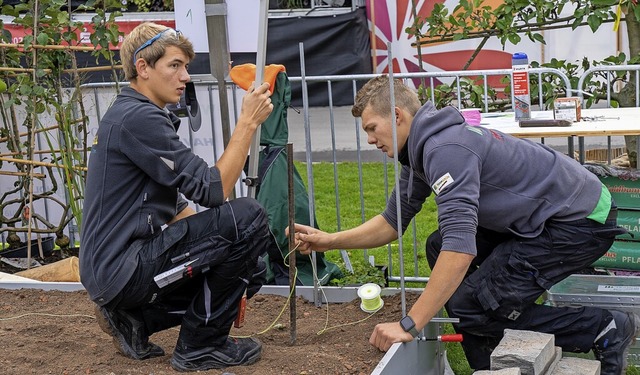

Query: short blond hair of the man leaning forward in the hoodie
351;75;421;117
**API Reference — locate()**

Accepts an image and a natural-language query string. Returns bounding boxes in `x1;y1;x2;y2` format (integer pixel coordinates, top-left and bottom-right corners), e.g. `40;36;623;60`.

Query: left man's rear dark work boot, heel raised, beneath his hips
95;305;164;359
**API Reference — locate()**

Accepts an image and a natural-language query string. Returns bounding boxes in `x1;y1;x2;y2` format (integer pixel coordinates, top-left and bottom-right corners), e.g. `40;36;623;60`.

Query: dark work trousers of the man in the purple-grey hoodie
426;207;626;370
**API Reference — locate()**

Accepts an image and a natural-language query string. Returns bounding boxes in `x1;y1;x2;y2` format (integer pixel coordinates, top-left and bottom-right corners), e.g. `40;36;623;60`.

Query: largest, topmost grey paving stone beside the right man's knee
491;329;556;375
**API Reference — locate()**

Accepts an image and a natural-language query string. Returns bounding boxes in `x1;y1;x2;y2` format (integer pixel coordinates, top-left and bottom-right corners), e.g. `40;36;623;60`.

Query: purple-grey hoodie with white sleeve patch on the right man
382;102;602;255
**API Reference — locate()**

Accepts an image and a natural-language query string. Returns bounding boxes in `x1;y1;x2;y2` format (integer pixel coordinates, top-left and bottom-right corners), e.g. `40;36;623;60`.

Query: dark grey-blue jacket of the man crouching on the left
80;87;223;305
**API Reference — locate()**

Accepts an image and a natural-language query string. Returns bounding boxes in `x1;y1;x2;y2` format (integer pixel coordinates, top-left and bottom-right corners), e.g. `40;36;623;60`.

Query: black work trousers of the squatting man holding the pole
107;198;275;347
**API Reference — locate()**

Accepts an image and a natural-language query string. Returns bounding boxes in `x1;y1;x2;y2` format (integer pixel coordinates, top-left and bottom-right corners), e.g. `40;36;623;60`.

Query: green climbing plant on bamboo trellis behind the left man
0;0;121;253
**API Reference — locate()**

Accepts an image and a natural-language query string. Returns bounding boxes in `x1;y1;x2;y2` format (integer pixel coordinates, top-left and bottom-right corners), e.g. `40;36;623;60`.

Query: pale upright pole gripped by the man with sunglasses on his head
245;0;269;198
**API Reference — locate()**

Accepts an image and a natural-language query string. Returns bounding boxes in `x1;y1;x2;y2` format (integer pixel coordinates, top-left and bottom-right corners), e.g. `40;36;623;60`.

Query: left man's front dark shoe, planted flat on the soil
171;337;262;371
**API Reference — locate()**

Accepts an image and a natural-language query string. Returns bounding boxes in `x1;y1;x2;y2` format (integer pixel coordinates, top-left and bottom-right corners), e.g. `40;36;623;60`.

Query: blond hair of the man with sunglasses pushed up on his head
120;22;196;81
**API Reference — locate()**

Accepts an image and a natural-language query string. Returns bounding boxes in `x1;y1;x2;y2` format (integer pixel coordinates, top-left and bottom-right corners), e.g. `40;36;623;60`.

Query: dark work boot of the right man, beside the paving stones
593;310;640;375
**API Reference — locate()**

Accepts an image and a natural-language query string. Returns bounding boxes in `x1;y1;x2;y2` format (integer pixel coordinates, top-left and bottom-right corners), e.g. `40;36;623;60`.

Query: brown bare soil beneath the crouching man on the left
0;289;422;375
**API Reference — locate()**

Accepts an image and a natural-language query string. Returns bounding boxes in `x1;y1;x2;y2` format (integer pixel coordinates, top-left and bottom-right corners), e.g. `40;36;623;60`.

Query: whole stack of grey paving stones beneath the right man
473;329;600;375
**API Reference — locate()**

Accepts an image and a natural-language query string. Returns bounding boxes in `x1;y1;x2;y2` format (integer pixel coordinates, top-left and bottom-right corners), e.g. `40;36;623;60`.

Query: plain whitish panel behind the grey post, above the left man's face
174;0;268;53
